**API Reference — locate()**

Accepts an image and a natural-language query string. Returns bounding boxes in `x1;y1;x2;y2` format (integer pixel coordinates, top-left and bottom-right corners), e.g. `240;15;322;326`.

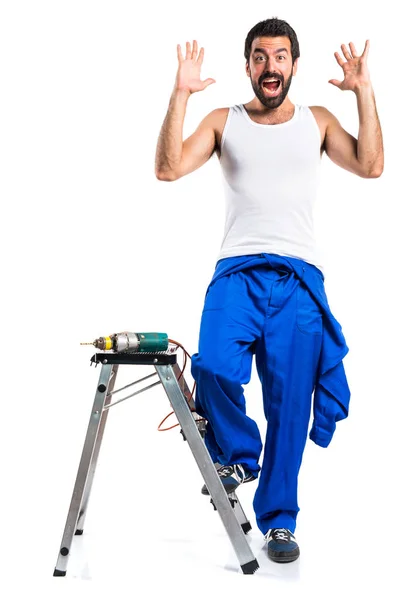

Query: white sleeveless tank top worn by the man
217;104;323;271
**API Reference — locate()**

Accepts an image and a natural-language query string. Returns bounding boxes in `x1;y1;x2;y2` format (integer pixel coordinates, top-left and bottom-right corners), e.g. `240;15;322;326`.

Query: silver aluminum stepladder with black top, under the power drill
54;352;259;577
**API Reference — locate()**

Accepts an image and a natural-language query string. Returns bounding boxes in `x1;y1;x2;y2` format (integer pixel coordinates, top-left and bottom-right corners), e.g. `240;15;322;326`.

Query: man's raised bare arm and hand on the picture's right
321;40;384;178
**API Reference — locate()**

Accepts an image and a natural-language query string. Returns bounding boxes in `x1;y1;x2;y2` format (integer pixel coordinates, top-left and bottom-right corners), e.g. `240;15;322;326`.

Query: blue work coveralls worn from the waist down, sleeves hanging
191;253;350;534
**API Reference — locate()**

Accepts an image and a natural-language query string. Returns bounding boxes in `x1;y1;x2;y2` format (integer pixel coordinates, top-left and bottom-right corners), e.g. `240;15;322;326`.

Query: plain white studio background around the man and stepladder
0;0;418;598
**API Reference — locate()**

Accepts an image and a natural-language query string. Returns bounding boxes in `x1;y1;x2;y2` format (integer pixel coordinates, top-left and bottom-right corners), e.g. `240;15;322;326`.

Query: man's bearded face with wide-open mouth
245;37;297;108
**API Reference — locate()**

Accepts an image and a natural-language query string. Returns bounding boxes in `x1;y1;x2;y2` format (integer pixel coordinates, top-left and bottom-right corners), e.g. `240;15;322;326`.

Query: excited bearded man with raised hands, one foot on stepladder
155;18;383;562
